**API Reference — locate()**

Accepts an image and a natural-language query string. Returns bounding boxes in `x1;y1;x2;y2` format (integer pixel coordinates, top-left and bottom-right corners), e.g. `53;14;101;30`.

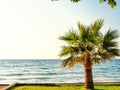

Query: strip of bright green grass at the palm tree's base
9;85;120;90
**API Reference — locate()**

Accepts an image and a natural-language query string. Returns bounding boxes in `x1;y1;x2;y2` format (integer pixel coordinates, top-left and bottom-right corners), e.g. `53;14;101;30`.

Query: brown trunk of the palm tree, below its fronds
84;55;94;89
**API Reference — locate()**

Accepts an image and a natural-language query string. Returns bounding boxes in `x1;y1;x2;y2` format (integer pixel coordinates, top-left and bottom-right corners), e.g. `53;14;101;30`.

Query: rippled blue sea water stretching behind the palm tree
0;59;120;84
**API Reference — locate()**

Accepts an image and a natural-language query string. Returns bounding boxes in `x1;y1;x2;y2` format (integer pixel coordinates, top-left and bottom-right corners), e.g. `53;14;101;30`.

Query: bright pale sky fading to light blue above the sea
0;0;120;59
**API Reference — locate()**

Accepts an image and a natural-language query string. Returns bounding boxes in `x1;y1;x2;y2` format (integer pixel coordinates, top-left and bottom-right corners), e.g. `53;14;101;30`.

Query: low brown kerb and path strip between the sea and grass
0;82;120;90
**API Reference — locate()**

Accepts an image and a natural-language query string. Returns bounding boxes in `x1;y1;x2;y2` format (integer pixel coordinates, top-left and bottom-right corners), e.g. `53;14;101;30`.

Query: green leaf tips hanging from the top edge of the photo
52;0;117;8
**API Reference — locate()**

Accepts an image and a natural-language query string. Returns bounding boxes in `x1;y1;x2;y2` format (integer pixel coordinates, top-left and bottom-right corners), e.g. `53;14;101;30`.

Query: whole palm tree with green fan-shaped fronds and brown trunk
59;19;120;89
